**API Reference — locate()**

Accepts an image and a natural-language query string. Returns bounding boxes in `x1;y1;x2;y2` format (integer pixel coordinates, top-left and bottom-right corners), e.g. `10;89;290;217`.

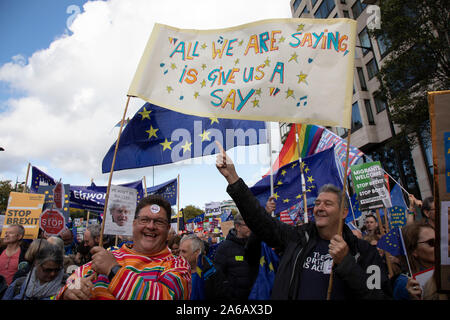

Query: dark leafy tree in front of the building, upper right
371;0;450;148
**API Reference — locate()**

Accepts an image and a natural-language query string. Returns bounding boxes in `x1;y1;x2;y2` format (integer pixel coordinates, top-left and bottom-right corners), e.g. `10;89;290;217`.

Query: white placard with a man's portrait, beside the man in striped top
104;185;137;236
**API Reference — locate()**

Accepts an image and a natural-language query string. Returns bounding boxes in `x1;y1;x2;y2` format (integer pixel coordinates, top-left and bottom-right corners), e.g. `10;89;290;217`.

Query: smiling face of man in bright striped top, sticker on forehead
133;204;170;255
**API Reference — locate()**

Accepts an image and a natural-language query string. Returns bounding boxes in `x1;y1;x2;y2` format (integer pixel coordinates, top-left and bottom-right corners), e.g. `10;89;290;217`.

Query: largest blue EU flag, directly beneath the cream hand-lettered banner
102;103;267;173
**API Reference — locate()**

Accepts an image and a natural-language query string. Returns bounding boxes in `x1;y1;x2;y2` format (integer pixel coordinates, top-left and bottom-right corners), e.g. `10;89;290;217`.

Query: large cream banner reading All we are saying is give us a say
128;18;356;128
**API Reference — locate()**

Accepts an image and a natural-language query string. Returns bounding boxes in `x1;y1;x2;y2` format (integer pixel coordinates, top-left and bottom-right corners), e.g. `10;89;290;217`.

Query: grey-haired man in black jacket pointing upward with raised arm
216;145;391;300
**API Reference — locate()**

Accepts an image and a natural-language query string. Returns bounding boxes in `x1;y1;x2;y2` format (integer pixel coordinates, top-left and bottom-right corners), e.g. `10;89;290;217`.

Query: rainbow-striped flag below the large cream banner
263;124;324;177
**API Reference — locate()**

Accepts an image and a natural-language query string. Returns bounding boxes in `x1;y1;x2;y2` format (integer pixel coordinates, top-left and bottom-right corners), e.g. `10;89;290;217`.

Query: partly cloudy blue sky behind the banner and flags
0;0;292;208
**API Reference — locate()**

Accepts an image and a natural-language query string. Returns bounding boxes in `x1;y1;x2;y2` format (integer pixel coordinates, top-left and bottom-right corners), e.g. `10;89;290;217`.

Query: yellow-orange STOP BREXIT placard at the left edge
1;192;45;239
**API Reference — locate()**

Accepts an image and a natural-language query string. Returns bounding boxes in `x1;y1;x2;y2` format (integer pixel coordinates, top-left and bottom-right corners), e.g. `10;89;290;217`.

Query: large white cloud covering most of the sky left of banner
0;0;291;208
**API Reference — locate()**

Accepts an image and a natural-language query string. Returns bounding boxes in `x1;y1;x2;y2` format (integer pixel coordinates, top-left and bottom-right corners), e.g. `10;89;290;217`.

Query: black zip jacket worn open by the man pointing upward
227;179;392;300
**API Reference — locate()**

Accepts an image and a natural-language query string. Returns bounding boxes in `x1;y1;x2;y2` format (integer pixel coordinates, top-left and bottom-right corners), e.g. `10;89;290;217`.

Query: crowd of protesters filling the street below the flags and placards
0;150;448;300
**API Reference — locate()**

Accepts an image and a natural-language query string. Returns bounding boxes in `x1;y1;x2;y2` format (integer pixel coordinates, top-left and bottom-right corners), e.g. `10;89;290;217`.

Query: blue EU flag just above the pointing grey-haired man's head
250;147;342;213
